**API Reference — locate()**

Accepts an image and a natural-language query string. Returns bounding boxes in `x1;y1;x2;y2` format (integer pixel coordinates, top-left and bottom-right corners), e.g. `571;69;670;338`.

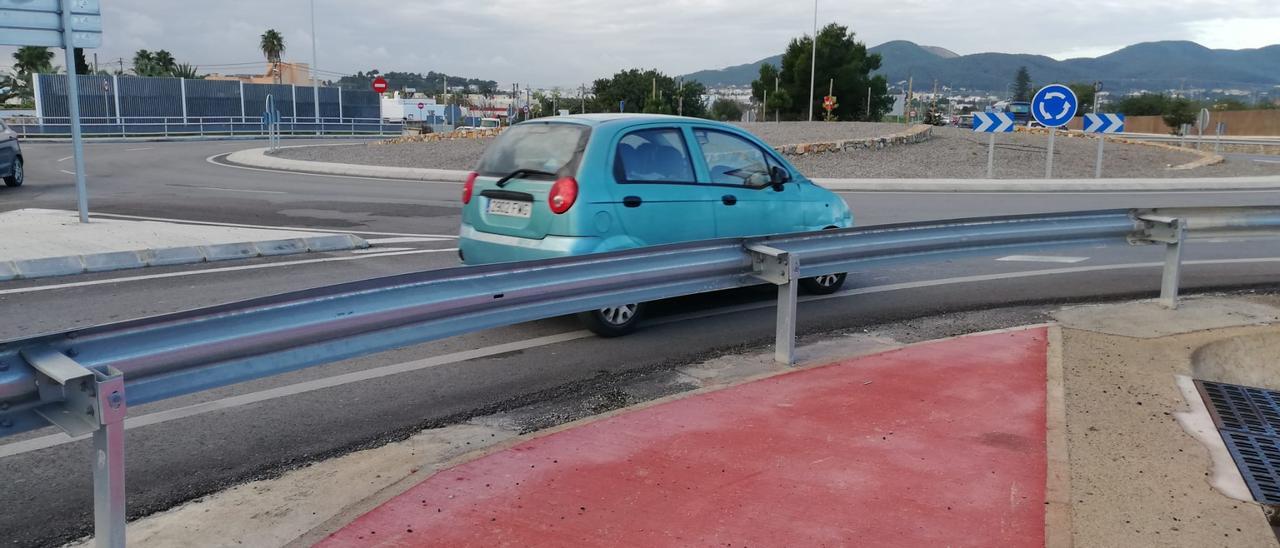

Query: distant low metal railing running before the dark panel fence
5;117;403;138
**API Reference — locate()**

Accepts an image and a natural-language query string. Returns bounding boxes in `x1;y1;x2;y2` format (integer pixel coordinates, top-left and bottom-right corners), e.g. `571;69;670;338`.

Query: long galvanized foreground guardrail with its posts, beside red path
0;207;1280;545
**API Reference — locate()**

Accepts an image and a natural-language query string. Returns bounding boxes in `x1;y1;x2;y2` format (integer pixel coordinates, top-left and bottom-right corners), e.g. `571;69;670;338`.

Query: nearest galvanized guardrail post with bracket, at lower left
22;347;127;548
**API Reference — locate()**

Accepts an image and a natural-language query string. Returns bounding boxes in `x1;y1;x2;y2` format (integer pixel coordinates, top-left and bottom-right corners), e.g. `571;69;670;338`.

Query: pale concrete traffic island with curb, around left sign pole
0;209;369;280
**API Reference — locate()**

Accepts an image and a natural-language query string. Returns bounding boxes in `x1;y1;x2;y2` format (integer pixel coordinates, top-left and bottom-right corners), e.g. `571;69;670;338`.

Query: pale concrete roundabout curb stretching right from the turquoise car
813;175;1280;192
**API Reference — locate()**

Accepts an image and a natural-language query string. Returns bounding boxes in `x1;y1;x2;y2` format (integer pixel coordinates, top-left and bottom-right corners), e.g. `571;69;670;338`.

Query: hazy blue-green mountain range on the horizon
684;40;1280;92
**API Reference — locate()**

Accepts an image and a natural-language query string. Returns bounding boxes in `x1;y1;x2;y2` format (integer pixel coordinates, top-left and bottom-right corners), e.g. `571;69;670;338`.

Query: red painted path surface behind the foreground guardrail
319;328;1047;547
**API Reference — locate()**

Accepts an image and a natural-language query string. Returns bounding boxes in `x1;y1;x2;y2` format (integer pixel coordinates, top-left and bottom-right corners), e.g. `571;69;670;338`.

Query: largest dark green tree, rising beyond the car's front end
768;23;893;120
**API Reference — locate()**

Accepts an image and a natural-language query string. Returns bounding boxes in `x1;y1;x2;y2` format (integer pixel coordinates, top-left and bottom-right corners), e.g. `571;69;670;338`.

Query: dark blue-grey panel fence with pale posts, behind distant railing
35;74;381;119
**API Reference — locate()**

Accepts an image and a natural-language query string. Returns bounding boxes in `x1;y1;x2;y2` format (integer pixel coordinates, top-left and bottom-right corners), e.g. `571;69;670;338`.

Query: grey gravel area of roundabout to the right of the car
790;128;1280;179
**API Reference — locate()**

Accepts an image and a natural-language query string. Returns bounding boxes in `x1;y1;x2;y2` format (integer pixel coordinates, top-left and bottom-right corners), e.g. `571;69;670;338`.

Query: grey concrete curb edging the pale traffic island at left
0;234;369;282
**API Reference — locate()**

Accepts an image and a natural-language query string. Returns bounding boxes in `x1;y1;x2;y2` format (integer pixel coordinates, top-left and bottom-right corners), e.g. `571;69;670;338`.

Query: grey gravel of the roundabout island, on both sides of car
275;122;1280;179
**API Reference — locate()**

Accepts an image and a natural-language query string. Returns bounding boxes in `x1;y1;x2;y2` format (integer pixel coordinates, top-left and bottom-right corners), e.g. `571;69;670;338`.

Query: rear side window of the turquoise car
613;128;696;183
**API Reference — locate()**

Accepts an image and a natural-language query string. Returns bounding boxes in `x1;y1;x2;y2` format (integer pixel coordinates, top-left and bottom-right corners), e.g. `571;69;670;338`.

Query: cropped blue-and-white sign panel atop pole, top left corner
0;0;102;47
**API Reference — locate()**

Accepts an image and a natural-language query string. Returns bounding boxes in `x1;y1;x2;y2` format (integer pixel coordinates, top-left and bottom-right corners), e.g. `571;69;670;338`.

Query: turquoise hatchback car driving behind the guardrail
458;114;854;337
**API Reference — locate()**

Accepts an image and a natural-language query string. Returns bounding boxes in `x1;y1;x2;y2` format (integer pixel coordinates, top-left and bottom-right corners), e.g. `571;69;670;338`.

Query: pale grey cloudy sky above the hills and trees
0;0;1280;87
